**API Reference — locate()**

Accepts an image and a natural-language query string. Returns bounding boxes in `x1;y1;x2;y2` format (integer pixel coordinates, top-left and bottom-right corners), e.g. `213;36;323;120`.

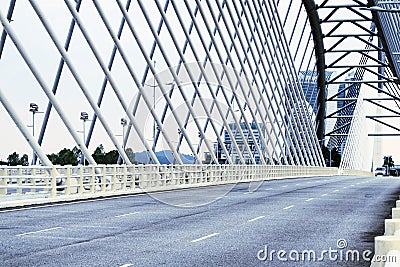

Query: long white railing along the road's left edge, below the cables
0;165;338;202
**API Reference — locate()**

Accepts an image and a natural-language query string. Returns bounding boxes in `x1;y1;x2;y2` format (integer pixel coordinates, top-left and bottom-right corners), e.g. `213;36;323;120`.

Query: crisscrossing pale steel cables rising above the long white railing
0;0;325;166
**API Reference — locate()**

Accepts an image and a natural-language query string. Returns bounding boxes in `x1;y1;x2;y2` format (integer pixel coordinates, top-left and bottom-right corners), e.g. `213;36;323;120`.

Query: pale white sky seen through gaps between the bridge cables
0;1;400;165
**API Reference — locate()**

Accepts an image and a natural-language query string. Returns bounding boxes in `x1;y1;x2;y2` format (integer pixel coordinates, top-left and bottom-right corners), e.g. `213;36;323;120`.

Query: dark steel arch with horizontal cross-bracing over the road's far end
290;0;400;170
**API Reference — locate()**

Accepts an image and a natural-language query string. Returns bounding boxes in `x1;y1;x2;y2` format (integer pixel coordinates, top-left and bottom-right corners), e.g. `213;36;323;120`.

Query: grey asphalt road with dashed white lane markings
0;177;400;266
